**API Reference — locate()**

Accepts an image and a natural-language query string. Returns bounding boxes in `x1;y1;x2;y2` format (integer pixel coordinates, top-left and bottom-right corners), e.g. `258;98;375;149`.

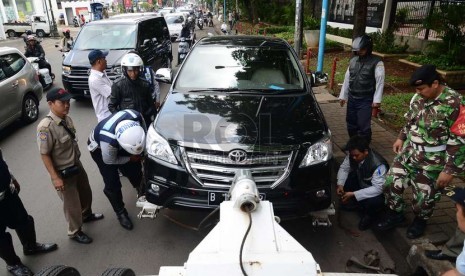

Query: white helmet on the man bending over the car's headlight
115;120;145;155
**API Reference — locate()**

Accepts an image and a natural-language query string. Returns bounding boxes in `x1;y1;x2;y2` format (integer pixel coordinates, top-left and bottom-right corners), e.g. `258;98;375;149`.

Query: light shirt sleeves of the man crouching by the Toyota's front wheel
337;155;387;201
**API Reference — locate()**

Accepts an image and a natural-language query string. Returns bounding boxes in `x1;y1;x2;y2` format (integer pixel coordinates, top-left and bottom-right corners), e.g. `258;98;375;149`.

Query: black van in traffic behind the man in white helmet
62;15;172;98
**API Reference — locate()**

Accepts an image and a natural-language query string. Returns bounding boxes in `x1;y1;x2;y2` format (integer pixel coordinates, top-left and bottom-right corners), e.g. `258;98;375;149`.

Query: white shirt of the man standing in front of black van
89;69;113;122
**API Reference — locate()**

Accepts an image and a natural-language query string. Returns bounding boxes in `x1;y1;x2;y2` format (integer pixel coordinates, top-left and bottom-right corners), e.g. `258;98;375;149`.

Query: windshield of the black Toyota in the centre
173;46;304;92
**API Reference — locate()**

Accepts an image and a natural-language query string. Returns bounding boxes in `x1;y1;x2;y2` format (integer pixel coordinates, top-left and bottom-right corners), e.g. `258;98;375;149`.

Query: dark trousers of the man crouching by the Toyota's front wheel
344;172;385;216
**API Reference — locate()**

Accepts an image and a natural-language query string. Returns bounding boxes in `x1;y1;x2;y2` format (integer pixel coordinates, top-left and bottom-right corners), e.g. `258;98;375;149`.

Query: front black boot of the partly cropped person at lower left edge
15;216;58;255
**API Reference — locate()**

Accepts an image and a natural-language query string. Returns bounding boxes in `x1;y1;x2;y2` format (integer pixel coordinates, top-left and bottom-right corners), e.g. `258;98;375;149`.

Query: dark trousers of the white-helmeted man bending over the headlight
90;148;142;215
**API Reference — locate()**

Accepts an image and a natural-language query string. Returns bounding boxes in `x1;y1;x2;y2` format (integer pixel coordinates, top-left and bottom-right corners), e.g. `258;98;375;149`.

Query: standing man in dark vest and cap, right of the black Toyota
339;35;384;142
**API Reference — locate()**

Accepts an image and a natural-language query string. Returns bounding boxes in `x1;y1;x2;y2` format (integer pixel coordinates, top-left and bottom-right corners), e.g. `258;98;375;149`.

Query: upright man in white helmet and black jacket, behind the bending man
108;53;157;125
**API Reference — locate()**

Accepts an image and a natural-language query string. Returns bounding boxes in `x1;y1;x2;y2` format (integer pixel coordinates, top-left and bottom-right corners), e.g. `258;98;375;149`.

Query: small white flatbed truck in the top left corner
3;15;50;37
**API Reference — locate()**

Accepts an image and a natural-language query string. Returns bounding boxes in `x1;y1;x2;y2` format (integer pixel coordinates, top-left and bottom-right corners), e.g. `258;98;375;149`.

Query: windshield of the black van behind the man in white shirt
73;24;137;50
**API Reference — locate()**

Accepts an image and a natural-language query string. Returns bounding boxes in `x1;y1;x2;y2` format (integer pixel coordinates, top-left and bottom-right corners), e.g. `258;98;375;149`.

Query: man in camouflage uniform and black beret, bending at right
378;65;465;239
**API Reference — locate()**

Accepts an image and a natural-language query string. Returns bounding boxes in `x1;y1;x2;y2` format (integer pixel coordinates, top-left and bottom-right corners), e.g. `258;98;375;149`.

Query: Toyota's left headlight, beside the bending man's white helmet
145;126;178;165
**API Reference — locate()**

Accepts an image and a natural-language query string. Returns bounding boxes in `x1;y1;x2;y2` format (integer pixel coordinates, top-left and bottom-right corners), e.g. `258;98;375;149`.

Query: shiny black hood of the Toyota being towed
155;92;328;147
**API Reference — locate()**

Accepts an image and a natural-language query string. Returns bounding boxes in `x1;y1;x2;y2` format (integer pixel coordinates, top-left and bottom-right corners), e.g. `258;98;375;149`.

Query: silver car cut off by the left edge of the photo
0;47;42;129
